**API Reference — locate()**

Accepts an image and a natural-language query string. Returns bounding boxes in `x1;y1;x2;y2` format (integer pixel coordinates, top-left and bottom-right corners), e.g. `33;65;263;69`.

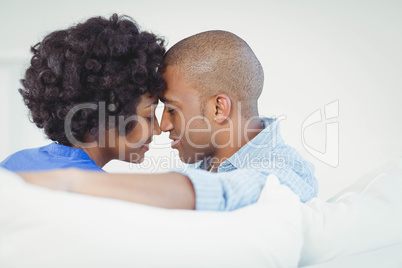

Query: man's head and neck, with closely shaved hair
161;31;264;166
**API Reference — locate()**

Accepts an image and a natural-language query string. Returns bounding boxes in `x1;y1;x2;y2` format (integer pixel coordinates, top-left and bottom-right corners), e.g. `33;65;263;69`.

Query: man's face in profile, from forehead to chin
161;66;215;163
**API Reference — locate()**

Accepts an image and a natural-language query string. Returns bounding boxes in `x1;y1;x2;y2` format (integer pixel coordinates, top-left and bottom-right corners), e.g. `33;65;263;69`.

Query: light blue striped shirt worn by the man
179;118;318;210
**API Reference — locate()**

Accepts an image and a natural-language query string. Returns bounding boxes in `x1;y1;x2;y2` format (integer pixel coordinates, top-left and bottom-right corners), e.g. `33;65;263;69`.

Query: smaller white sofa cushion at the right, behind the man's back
300;157;402;266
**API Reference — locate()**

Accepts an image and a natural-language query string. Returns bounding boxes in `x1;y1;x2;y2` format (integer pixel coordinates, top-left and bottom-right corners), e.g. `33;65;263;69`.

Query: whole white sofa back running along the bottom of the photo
0;158;402;268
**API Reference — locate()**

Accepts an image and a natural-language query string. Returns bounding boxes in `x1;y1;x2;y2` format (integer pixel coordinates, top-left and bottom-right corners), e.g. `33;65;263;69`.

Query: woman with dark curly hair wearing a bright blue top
0;14;165;171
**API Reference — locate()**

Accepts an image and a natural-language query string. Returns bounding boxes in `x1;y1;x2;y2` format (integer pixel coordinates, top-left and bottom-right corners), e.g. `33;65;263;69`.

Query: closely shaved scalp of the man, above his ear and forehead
164;31;264;117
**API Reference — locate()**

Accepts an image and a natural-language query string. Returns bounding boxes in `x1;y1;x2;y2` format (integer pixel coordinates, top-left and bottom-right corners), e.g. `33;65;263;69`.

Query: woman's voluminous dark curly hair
19;14;165;146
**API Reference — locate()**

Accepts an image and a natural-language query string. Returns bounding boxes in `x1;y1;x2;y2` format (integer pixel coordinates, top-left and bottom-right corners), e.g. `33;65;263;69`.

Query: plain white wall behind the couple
0;0;402;198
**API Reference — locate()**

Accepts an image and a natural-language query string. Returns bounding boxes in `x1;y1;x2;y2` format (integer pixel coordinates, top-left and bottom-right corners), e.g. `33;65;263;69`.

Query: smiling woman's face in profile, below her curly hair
107;94;161;163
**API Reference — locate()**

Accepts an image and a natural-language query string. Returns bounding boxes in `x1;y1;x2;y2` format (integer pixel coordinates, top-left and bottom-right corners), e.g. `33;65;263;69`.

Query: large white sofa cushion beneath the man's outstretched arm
0;170;302;268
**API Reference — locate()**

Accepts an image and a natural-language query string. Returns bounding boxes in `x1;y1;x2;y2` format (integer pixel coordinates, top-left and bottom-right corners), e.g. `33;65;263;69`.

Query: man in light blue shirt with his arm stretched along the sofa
22;31;318;210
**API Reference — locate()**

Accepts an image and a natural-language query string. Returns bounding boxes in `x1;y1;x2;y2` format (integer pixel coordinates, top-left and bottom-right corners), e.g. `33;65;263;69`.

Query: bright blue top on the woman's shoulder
0;142;104;172
